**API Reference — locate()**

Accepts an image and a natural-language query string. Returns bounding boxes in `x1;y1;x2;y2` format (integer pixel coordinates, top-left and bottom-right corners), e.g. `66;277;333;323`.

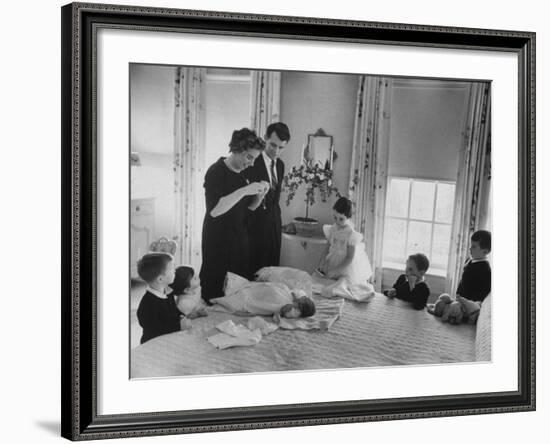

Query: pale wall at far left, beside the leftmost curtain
130;65;176;238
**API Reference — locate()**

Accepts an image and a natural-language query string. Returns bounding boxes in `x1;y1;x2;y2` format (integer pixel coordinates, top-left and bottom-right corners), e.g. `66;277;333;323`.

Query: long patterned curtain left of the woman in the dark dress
174;67;206;272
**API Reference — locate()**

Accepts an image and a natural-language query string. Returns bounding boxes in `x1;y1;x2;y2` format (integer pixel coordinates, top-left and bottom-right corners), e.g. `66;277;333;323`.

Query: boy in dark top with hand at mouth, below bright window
384;253;430;310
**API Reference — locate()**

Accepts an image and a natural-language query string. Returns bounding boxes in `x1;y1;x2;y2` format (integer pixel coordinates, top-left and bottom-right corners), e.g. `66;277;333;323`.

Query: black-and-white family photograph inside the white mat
127;63;492;379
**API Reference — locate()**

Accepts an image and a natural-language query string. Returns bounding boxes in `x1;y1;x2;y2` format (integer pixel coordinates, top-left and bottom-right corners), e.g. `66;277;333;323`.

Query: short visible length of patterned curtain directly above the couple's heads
250;71;281;137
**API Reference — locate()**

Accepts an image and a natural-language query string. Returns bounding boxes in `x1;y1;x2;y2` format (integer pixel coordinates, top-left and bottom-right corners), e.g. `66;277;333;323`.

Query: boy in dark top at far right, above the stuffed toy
456;230;491;302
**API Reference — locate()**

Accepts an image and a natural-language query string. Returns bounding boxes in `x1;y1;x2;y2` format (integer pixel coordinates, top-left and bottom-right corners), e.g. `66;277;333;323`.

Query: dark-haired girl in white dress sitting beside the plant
318;197;372;284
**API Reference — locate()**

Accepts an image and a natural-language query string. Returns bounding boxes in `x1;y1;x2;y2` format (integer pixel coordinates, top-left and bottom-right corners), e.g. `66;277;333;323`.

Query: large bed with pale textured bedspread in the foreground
130;278;491;378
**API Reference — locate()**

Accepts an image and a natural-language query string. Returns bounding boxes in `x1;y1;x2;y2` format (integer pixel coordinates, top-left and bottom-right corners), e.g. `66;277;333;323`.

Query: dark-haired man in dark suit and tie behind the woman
244;122;290;273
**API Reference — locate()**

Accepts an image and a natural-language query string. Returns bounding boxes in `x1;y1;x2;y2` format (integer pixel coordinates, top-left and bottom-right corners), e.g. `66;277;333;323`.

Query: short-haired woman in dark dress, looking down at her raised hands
199;128;269;303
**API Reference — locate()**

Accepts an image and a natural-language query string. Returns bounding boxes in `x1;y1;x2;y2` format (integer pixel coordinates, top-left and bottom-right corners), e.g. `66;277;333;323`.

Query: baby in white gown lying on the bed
210;272;315;318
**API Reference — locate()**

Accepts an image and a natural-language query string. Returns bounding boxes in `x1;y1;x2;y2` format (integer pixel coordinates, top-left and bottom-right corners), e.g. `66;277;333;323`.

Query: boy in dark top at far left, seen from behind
137;253;187;344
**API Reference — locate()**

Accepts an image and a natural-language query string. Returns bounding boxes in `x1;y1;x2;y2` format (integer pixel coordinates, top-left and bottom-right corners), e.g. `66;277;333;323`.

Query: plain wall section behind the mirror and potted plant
281;72;357;223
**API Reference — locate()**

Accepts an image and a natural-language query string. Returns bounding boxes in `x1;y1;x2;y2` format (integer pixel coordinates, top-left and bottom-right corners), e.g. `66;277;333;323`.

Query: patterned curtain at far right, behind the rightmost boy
446;83;491;294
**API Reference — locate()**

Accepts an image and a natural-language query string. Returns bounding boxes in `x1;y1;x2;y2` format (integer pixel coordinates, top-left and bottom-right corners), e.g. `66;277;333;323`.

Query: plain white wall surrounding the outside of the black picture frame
4;0;550;444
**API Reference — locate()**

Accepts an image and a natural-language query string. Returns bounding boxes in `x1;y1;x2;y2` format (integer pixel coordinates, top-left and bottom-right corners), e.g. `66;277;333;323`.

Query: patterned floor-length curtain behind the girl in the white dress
349;76;392;291
